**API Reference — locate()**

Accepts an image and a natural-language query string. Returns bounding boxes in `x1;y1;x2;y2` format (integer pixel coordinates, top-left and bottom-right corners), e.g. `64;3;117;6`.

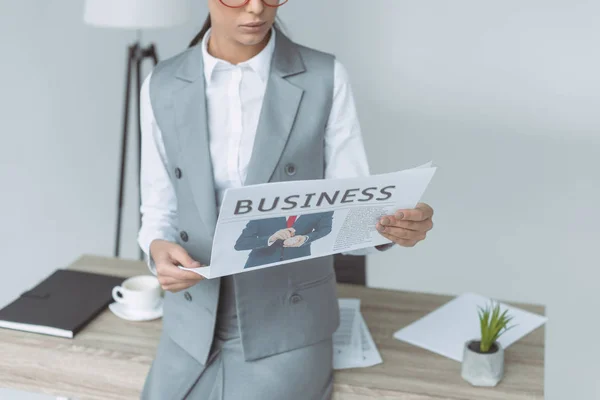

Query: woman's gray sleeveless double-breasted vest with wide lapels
150;31;339;364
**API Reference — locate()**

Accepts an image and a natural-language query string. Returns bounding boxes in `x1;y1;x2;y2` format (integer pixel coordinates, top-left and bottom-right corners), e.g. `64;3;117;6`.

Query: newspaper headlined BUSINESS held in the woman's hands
180;162;436;279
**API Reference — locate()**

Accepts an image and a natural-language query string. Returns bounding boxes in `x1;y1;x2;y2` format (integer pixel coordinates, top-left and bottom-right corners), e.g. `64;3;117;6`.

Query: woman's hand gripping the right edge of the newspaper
376;203;433;247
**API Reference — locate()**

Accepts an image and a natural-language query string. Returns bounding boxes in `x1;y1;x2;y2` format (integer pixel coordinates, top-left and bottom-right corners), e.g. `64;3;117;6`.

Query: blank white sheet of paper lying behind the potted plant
394;293;548;362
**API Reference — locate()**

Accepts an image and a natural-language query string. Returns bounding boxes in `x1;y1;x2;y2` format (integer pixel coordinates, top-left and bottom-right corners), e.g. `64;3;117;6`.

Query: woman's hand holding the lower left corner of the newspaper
150;239;204;293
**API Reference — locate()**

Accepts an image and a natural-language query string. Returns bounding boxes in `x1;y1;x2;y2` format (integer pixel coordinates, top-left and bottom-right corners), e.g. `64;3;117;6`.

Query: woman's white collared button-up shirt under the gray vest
138;29;372;255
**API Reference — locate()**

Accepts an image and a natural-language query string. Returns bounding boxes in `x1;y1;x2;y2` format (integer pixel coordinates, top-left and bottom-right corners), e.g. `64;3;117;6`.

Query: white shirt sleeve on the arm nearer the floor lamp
138;73;177;275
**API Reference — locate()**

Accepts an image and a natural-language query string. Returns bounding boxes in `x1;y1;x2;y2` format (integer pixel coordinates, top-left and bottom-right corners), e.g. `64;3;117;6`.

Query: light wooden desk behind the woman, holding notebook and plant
0;256;544;400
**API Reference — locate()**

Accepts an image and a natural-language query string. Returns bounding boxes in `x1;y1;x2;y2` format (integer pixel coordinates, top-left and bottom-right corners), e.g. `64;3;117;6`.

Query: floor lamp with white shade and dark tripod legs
84;0;191;259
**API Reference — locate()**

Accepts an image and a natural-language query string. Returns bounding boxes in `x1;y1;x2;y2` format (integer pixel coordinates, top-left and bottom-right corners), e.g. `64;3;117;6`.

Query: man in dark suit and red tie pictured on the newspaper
234;211;333;268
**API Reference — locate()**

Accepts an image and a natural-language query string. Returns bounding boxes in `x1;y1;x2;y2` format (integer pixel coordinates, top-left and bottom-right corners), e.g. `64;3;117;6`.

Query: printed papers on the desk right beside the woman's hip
333;299;382;369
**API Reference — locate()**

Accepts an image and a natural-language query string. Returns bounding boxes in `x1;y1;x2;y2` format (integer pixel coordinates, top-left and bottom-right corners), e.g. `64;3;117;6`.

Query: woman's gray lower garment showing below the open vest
141;277;333;400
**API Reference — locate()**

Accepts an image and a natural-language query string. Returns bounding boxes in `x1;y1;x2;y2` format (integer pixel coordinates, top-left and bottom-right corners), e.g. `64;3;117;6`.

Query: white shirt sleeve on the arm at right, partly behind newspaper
325;59;392;256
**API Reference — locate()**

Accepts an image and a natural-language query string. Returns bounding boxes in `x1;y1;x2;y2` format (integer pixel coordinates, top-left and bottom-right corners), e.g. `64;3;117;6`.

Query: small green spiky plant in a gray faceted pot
461;302;513;386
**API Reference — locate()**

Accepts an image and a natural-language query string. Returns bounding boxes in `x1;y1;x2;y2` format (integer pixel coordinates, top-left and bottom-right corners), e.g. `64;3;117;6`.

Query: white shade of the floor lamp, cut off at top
83;0;191;29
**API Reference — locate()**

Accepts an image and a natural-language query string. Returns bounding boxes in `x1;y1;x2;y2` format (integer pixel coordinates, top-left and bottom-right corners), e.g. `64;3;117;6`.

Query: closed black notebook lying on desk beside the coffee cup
0;269;125;338
